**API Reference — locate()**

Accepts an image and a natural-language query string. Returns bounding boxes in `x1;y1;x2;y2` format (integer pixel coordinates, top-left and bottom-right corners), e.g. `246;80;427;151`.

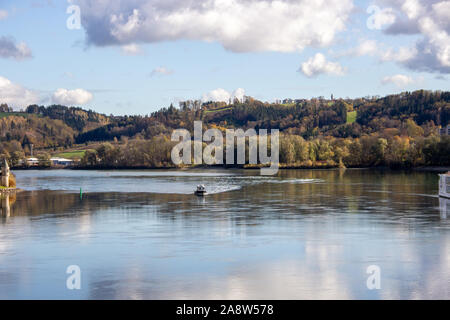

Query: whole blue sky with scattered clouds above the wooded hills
0;0;450;115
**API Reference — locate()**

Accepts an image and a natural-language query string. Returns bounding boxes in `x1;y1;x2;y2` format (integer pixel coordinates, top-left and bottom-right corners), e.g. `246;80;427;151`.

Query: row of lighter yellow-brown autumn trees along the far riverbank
76;133;450;168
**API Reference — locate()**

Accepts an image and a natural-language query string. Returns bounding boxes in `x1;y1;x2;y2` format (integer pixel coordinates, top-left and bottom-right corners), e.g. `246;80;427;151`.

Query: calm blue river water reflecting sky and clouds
0;170;450;299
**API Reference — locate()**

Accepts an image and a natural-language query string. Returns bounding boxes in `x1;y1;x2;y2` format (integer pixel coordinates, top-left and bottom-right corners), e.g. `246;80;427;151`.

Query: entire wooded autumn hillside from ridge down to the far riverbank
0;90;450;169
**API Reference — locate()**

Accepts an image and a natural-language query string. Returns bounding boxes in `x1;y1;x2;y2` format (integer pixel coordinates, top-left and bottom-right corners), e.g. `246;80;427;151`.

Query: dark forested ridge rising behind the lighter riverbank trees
76;91;450;143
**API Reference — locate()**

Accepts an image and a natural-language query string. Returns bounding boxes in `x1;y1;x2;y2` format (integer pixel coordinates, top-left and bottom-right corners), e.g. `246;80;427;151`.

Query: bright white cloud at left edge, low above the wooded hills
0;76;40;109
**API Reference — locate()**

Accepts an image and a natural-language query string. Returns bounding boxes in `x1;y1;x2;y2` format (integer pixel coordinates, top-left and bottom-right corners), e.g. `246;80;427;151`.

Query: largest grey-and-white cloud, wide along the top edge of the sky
74;0;353;52
